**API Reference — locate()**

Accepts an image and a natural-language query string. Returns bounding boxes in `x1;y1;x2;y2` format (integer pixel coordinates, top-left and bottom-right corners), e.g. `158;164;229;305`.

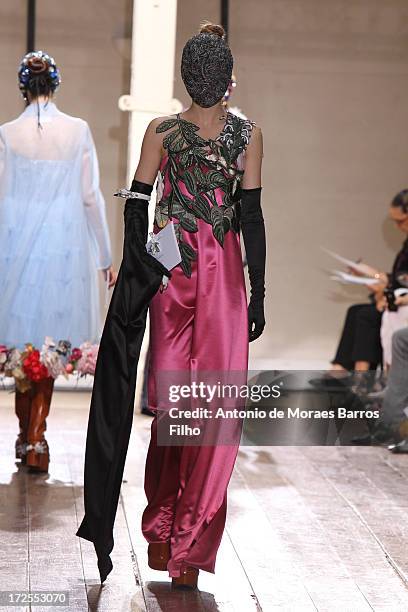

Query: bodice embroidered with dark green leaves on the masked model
154;112;255;277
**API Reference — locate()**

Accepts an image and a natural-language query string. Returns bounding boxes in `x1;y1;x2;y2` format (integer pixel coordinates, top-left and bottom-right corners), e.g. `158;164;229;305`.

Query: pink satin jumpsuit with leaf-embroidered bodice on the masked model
142;112;254;577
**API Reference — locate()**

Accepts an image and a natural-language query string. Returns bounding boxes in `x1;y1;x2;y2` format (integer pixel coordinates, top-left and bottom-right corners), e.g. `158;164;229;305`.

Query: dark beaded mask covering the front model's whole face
181;33;234;108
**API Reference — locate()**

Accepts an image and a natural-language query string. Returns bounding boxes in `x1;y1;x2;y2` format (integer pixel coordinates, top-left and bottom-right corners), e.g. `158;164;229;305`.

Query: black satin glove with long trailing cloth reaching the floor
76;181;171;582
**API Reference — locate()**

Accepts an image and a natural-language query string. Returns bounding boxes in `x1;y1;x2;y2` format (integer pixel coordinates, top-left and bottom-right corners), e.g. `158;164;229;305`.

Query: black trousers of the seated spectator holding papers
332;304;382;370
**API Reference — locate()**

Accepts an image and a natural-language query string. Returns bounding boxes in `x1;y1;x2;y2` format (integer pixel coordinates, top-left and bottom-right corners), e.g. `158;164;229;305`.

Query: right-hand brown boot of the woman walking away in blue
26;377;54;472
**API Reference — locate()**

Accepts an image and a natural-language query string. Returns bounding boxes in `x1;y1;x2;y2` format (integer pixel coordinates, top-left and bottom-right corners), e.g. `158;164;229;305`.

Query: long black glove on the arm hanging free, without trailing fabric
241;187;266;342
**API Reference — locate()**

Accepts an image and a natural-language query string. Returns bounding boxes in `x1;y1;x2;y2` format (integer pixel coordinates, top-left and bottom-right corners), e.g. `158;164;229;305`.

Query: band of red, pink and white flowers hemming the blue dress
0;336;99;392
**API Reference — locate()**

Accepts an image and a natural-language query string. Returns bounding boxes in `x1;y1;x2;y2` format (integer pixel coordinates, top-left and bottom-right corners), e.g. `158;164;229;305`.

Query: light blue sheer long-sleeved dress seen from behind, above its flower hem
0;102;112;348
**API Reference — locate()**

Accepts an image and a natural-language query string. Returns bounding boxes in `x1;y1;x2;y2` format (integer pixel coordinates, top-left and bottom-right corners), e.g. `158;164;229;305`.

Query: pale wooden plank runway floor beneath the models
0;391;408;612
